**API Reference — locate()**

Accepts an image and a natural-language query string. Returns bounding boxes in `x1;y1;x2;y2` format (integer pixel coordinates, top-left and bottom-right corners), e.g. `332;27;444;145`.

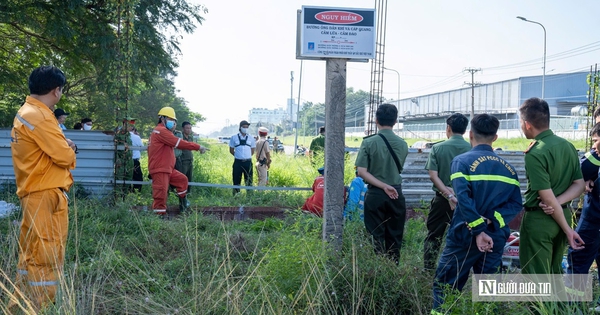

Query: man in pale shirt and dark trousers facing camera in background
229;120;256;196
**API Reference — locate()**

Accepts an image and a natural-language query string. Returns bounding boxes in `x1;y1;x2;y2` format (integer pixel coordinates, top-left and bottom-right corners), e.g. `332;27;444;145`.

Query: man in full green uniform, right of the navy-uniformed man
519;97;585;274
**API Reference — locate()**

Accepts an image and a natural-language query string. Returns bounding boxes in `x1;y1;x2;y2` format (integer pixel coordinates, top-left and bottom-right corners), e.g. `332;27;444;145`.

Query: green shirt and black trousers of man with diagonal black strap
355;129;408;262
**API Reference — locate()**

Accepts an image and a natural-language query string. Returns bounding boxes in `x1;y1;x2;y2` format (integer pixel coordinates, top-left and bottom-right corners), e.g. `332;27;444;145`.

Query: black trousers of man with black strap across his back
365;185;406;263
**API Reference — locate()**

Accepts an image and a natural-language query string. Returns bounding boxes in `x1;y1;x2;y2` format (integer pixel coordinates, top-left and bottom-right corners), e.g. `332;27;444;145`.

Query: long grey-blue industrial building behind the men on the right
354;72;589;139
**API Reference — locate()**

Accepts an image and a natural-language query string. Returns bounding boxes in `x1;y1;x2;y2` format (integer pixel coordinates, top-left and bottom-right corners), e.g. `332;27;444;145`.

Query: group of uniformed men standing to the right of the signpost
355;98;600;314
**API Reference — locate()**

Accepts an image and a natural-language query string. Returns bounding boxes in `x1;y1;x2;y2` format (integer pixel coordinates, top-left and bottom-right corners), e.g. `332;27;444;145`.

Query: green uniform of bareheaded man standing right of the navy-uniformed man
519;130;583;274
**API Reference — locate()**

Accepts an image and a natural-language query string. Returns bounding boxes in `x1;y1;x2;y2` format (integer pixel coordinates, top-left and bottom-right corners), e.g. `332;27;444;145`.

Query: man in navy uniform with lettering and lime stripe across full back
431;114;522;314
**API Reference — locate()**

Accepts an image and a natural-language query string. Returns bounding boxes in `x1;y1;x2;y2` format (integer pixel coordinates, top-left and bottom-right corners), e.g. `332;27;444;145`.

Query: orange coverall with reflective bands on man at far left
10;96;75;307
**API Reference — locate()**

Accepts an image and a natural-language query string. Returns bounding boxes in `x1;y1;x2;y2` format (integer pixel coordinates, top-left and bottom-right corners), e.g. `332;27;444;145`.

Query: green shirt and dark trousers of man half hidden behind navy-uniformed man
423;135;471;269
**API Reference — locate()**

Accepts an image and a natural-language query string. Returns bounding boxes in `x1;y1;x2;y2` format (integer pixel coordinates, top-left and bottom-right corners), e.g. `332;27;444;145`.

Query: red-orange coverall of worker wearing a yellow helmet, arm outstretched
148;123;200;214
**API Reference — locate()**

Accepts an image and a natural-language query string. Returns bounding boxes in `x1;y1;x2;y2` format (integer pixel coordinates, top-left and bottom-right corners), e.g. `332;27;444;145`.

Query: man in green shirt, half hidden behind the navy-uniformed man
423;113;471;270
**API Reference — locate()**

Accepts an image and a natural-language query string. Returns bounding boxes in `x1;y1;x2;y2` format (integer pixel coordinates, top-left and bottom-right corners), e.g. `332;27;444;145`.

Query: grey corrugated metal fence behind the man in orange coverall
0;129;115;197
